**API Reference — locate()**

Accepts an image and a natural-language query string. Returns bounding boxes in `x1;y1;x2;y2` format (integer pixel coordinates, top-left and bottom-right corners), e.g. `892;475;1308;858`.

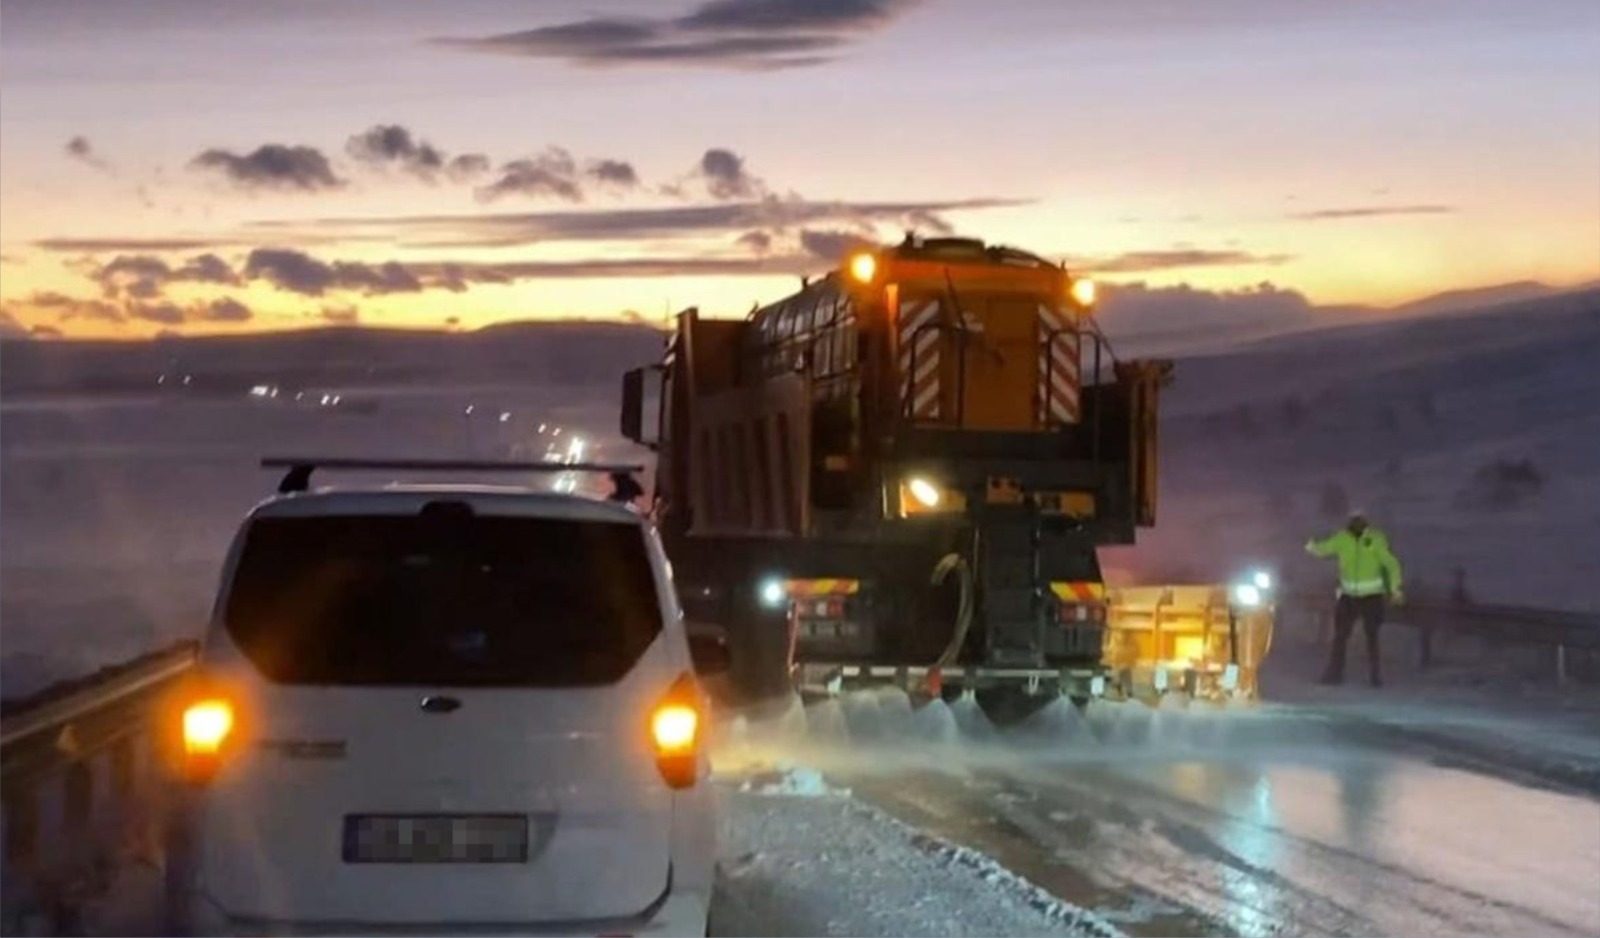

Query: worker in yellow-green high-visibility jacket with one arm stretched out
1306;511;1405;687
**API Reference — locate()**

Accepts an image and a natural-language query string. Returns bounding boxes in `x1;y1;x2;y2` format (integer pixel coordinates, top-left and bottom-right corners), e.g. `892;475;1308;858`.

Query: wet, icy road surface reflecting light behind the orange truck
726;685;1600;935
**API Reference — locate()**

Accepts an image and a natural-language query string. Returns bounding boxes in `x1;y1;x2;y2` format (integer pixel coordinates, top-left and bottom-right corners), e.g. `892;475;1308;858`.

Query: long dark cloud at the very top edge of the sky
442;0;914;70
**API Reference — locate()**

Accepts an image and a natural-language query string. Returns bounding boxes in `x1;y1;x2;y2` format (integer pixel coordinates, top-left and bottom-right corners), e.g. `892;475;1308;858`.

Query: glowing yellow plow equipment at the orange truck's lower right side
1102;571;1275;701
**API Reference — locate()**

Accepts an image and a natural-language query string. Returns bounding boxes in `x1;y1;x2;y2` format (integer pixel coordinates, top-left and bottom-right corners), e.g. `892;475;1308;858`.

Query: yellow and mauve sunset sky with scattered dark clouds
0;0;1600;338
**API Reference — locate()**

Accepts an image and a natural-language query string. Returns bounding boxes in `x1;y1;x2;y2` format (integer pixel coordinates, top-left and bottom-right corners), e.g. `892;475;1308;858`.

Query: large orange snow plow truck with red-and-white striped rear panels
622;235;1171;709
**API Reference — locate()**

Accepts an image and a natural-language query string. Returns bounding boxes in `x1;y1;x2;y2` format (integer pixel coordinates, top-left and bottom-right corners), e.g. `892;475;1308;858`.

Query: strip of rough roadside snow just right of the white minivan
712;768;1120;938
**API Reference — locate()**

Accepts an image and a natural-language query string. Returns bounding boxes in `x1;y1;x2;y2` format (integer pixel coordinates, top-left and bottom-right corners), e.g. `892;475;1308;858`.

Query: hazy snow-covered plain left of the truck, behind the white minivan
0;387;621;696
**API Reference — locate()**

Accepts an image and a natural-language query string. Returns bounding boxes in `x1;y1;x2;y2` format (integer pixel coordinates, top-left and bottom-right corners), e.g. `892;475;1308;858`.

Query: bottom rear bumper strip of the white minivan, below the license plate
166;869;710;938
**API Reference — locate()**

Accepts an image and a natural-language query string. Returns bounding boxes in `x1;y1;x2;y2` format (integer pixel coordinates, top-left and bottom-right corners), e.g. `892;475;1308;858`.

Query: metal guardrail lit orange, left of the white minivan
0;642;197;935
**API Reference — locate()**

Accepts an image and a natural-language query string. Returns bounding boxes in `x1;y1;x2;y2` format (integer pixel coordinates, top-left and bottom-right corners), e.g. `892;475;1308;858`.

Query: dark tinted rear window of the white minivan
222;506;661;687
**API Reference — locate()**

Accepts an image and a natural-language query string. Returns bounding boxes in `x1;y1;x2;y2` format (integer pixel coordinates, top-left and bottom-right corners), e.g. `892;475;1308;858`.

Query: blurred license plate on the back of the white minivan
344;815;528;863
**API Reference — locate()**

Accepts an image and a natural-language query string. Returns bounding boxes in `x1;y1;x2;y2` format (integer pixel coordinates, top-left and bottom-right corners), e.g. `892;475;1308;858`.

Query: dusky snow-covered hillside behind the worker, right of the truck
1102;291;1600;610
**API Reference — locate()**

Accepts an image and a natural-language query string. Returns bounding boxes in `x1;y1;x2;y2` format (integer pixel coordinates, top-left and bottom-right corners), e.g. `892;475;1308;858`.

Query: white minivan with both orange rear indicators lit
166;470;726;935
